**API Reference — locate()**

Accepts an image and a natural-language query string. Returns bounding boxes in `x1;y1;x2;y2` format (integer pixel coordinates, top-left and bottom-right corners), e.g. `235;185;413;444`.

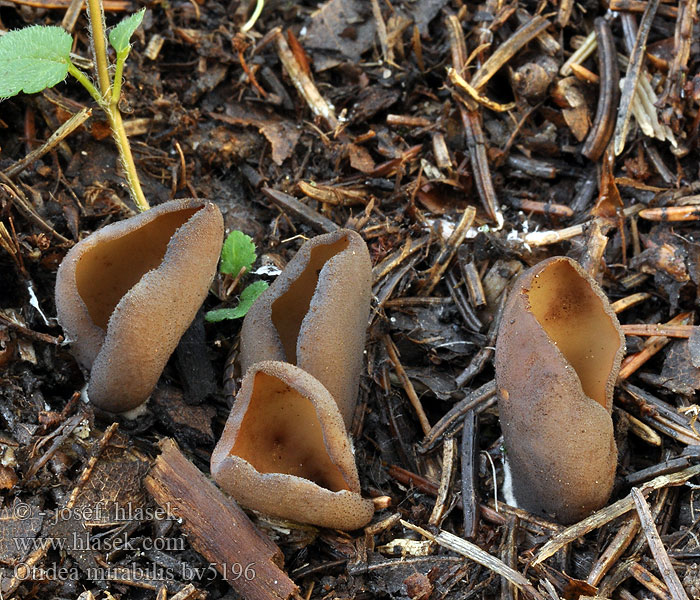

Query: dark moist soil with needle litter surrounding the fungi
0;0;700;600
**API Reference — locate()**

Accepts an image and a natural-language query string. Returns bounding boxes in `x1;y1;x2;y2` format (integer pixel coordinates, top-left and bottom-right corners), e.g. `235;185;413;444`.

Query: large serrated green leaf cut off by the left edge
0;25;73;100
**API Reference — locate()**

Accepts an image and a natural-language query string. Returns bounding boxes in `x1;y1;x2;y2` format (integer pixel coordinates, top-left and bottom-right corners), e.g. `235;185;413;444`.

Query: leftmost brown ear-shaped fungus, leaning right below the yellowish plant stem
56;199;223;412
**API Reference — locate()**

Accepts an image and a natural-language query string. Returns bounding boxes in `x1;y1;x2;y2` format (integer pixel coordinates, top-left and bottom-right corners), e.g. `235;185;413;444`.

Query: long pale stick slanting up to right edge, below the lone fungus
532;465;700;565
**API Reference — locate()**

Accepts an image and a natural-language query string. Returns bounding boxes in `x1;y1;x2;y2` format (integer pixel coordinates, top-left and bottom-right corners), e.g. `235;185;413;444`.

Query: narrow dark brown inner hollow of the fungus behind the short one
272;236;350;365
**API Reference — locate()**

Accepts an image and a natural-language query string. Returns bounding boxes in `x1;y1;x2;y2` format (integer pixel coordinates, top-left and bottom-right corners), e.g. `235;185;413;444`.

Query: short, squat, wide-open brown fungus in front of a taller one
211;361;374;530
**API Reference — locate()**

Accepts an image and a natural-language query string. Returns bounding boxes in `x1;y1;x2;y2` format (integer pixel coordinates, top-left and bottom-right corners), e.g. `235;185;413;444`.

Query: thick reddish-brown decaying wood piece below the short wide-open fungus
145;438;297;600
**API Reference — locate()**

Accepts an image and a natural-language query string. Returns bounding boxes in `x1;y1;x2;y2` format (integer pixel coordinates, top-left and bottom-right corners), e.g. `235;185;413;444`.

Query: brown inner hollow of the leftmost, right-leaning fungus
75;207;201;330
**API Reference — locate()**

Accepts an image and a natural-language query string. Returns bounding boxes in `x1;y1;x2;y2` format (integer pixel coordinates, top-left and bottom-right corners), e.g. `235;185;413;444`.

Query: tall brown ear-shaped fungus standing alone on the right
495;257;625;523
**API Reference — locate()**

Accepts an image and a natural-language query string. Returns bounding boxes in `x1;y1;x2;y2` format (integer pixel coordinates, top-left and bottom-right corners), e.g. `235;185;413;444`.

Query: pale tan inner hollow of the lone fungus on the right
528;260;620;408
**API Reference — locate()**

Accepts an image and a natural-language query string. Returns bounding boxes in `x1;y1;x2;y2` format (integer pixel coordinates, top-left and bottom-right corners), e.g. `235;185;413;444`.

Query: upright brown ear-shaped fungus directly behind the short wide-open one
240;229;372;427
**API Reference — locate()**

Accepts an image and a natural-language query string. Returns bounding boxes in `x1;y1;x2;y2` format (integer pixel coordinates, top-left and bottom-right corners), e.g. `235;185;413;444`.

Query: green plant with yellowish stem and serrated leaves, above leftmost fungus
0;5;149;211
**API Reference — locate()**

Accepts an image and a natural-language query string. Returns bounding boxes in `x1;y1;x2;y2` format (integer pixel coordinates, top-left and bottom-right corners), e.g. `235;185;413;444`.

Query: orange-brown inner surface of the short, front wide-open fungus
230;372;349;494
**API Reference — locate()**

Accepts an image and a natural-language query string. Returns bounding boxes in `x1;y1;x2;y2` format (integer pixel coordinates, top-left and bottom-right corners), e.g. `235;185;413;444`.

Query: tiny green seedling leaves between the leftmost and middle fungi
204;231;267;323
